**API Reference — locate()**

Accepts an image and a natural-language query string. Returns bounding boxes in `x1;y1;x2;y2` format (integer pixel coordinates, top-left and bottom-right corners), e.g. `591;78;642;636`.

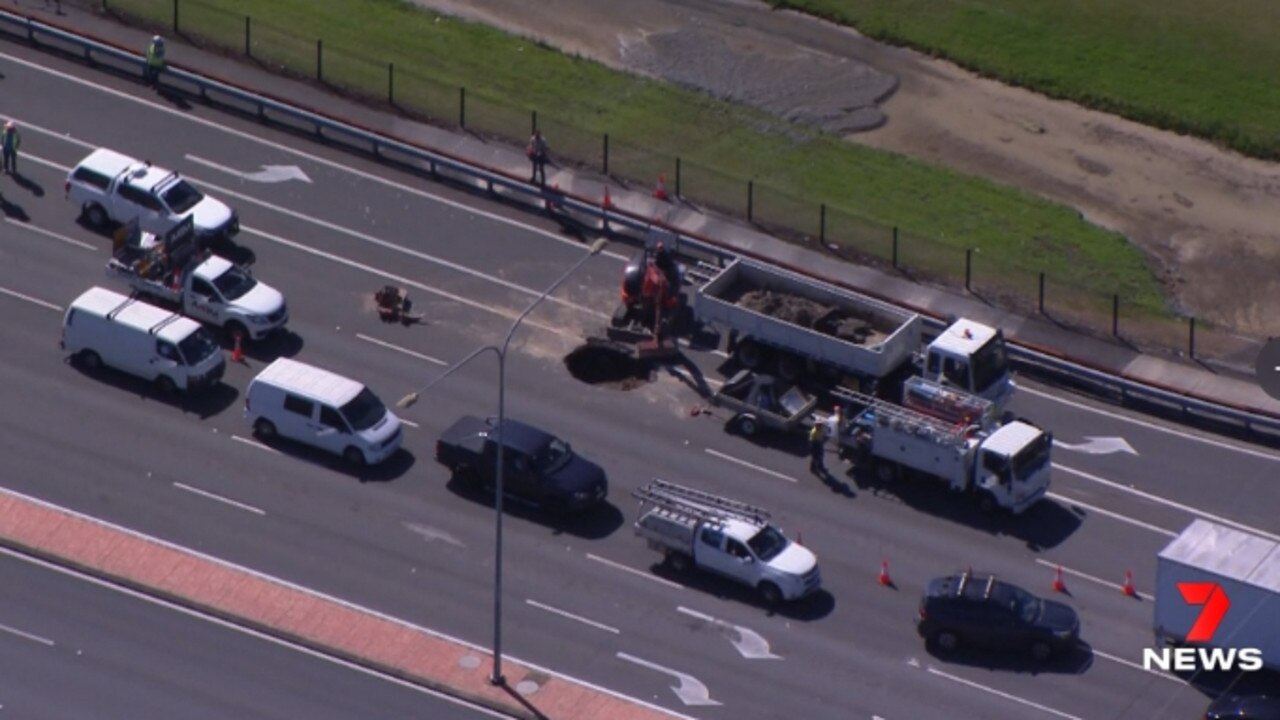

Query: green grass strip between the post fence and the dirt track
110;0;1166;313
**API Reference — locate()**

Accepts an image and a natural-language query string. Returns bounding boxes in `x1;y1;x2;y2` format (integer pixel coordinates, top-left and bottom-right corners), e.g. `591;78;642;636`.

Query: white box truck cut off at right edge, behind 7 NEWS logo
1144;519;1280;671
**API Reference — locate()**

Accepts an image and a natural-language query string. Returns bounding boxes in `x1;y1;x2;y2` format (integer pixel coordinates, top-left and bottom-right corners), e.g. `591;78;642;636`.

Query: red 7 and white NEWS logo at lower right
1142;583;1262;673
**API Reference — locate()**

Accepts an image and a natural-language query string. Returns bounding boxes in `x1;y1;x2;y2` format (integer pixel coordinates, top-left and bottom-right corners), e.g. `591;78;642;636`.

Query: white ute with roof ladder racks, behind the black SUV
631;479;822;606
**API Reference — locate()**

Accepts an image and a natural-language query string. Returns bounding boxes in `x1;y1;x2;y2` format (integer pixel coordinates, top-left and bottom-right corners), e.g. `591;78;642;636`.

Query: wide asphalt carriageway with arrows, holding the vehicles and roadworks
0;39;1280;720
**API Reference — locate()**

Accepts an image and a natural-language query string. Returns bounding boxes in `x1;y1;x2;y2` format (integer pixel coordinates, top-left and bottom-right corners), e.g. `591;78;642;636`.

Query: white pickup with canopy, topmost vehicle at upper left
65;147;239;246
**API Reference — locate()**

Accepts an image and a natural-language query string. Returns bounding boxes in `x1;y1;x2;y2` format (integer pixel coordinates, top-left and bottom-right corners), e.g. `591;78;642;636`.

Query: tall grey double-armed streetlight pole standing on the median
396;237;608;685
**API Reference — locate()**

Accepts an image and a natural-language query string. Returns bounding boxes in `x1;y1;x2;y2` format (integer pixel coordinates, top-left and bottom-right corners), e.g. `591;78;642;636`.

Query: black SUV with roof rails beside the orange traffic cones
915;571;1080;661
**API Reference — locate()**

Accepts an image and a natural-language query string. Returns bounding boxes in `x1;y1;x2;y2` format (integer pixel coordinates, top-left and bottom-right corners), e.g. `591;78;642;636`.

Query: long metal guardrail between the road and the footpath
10;10;1280;441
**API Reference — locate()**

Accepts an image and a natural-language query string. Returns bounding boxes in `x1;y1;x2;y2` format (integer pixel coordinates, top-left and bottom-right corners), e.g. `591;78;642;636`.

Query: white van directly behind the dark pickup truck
244;357;403;465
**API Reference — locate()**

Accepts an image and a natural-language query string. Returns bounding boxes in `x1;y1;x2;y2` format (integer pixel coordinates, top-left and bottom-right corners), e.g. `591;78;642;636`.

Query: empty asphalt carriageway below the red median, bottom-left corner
0;545;504;720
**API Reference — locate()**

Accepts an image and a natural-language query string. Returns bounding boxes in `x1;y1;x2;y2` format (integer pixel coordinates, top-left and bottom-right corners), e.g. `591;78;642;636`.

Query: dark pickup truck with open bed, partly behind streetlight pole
435;415;609;511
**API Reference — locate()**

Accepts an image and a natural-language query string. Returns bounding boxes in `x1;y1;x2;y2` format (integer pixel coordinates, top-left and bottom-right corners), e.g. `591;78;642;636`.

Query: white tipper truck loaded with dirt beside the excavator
692;260;1014;409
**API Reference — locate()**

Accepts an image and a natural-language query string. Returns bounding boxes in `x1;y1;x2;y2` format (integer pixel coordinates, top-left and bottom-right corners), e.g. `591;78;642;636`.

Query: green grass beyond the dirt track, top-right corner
769;0;1280;160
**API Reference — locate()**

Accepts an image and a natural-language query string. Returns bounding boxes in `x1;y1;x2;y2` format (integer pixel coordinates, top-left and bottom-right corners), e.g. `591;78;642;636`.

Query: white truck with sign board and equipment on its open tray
106;218;289;341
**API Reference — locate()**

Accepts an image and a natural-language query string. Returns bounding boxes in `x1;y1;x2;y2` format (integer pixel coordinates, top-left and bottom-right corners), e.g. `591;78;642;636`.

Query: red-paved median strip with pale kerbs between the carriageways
0;488;687;720
